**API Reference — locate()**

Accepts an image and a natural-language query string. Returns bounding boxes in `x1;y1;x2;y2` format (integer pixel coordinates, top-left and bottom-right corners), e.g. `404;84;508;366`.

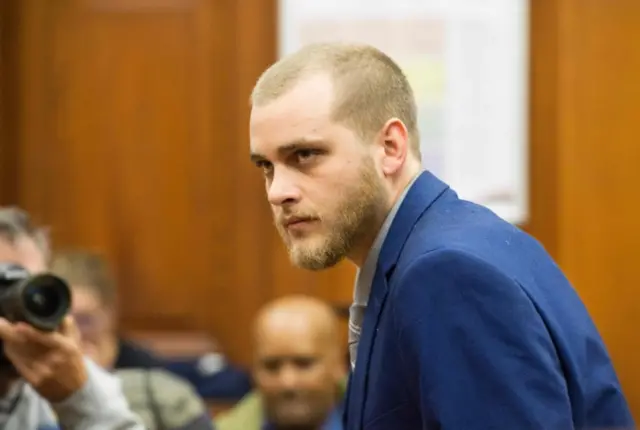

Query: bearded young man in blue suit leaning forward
250;44;634;430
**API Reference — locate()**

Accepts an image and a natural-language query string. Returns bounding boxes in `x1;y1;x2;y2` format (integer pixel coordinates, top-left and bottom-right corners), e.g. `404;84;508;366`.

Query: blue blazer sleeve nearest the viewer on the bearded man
393;250;573;430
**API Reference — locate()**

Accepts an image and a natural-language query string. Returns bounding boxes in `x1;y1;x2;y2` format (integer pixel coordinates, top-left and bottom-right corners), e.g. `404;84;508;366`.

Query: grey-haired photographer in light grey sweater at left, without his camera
0;208;144;430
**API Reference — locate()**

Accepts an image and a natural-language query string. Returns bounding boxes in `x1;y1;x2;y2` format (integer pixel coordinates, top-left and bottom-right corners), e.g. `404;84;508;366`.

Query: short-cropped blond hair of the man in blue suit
251;43;420;158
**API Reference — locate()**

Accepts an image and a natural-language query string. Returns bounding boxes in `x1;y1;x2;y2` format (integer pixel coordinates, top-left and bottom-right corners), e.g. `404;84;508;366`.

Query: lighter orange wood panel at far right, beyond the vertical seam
558;0;640;418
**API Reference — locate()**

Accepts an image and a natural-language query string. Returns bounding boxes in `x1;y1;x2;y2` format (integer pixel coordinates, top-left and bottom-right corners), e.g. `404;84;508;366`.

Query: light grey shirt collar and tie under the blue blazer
349;172;422;369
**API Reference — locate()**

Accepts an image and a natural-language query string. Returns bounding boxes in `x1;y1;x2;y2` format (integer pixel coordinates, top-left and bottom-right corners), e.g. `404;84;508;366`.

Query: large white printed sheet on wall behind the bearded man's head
279;0;529;223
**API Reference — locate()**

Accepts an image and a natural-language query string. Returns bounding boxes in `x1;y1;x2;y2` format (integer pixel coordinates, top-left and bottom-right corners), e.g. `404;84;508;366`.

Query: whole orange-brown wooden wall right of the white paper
527;0;640;417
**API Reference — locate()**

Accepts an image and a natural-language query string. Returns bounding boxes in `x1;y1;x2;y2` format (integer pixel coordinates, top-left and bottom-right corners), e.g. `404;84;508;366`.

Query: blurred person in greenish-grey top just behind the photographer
51;251;218;430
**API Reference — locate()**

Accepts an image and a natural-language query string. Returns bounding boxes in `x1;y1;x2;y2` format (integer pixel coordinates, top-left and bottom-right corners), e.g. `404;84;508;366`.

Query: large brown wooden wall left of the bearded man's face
8;0;273;362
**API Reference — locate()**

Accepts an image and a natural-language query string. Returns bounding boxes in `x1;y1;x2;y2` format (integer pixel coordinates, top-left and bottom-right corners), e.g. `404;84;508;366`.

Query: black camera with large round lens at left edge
0;262;71;331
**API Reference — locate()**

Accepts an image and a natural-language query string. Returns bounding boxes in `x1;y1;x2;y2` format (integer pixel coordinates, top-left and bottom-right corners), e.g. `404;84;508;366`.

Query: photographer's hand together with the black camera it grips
0;263;87;402
